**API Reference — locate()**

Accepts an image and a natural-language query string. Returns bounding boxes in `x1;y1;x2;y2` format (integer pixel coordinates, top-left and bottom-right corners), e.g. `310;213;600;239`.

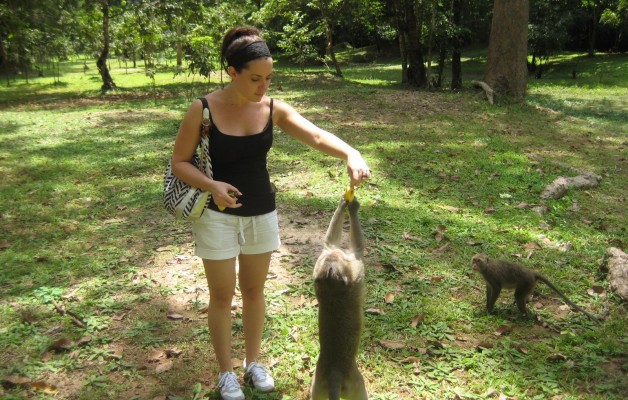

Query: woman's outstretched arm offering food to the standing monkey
273;100;371;186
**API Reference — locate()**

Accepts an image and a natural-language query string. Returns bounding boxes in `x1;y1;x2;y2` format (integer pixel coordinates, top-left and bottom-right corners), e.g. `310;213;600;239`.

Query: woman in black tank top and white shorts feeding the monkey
172;27;370;400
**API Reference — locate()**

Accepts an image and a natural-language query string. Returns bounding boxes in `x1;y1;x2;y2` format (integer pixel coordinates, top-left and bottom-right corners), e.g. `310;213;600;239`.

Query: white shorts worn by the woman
192;210;281;260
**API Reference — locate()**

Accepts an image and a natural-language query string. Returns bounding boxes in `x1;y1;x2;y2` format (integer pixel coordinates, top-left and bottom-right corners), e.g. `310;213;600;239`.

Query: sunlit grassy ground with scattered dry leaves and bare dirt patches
0;50;628;399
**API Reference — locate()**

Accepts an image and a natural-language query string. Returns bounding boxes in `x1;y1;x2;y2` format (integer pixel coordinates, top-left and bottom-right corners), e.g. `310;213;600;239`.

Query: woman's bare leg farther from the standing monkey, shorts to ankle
203;258;236;372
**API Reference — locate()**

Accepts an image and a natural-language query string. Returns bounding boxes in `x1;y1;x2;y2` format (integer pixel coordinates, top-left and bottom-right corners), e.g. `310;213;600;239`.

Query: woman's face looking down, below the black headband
229;57;273;102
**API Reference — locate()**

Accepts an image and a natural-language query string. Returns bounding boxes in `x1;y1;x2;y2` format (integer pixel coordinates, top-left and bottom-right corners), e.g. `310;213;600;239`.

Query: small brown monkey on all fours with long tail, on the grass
471;253;600;324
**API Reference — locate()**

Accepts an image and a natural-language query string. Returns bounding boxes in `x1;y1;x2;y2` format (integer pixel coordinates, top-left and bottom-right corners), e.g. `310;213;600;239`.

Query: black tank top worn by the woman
208;99;275;217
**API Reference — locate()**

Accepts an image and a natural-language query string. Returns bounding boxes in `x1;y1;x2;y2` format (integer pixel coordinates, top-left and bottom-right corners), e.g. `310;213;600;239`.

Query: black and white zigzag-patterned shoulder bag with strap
164;97;213;221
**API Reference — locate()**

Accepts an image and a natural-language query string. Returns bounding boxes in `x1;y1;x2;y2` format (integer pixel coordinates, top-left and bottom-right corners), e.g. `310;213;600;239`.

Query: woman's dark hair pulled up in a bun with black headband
220;26;271;72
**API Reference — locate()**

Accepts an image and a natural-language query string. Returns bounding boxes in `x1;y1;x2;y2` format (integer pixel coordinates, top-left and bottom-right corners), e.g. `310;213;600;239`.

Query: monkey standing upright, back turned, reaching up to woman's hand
310;198;368;400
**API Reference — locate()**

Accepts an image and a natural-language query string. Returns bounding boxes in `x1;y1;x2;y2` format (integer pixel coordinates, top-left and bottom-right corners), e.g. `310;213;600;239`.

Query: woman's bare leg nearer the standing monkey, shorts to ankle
238;252;272;364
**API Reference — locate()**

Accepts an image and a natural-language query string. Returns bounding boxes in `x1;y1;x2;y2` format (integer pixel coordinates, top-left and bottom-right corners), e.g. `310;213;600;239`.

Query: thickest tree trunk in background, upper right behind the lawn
484;0;530;101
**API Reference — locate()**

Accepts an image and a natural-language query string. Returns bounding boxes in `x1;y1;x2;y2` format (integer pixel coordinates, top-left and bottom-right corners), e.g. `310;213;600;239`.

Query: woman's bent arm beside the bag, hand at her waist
172;99;241;208
